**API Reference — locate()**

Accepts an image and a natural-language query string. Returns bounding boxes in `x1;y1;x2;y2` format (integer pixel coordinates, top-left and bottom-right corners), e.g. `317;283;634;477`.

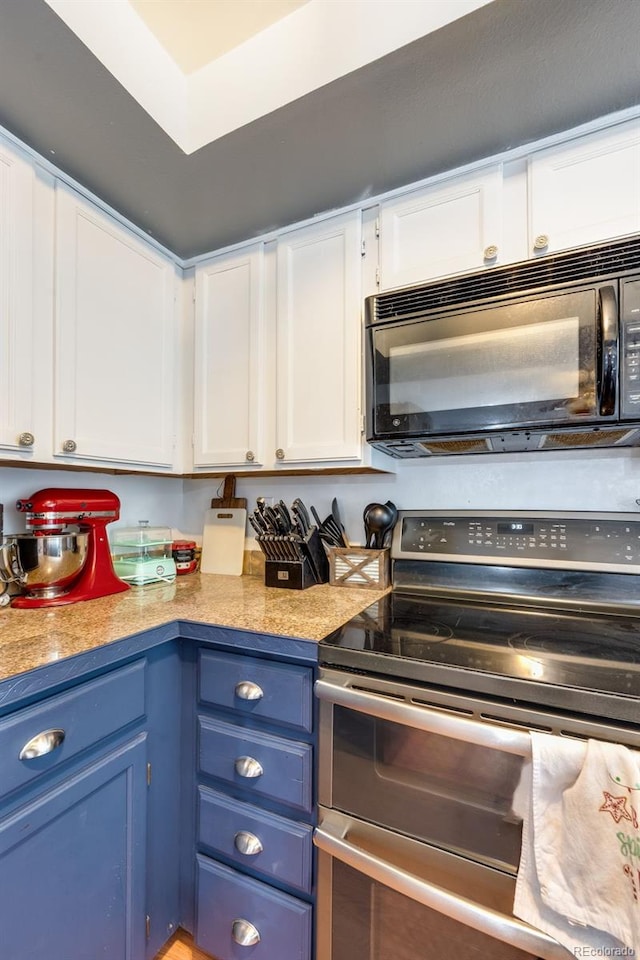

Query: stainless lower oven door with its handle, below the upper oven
314;808;573;960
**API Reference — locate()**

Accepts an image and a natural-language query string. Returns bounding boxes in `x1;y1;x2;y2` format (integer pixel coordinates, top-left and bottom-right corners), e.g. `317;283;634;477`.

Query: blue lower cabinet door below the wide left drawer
0;734;147;960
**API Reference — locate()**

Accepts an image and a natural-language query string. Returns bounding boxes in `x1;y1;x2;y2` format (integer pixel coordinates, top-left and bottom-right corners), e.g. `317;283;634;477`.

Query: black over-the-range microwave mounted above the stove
365;235;640;457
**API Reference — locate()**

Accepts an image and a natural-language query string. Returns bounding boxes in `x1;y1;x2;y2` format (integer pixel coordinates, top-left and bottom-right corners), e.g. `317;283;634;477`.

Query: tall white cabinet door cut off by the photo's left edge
0;141;35;457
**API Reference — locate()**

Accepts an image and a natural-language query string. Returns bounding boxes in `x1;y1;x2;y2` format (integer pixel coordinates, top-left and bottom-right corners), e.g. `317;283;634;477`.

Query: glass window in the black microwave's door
370;288;599;435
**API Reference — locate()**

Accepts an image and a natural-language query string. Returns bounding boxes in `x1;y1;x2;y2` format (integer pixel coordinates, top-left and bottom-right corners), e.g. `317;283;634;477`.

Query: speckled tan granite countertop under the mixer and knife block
0;573;388;681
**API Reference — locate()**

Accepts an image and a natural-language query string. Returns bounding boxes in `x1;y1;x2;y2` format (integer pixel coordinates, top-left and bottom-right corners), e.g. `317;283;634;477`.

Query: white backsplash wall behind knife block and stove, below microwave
183;450;640;547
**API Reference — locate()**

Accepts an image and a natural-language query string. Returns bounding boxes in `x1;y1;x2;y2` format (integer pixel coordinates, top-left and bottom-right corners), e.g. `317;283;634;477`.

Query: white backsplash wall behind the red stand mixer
0;466;183;534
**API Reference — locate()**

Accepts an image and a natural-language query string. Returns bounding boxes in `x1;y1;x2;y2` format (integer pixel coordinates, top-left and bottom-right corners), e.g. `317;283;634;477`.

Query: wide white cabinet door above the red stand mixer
54;183;177;467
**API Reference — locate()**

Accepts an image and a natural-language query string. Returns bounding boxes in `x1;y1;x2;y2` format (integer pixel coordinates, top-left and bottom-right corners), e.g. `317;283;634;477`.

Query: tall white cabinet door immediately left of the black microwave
275;211;362;465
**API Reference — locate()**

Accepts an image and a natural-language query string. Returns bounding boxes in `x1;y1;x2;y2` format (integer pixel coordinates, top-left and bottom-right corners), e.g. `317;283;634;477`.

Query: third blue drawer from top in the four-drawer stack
198;787;313;893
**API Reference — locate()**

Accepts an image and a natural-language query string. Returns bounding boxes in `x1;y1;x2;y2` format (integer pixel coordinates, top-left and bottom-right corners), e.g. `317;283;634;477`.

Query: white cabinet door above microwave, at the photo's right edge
529;119;640;254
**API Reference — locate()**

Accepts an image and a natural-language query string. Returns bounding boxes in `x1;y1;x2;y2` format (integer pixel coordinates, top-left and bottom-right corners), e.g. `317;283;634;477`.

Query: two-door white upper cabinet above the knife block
194;211;371;472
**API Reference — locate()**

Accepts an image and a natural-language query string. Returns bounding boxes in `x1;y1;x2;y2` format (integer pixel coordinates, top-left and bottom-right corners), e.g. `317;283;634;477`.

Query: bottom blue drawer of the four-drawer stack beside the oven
196;856;312;960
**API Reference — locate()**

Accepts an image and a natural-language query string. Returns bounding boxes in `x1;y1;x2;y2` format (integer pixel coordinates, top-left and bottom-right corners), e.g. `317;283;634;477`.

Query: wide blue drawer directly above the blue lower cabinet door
0;660;146;796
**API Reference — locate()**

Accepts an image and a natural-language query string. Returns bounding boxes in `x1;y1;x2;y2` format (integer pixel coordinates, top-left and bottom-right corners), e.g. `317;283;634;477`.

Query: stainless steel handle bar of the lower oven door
313;810;569;960
